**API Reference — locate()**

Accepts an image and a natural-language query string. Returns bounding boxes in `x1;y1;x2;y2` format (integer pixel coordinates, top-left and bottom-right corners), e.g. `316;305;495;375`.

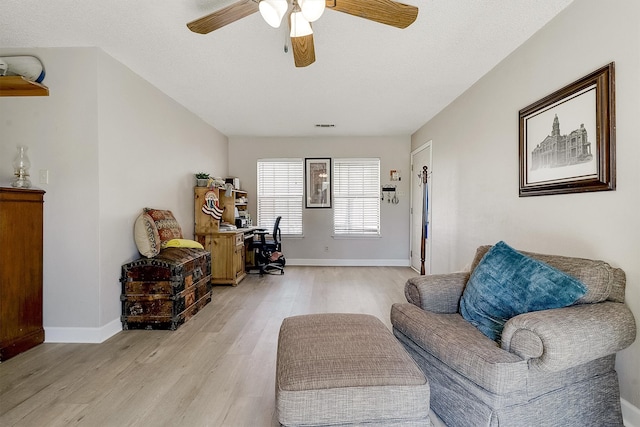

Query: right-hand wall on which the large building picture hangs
412;0;640;407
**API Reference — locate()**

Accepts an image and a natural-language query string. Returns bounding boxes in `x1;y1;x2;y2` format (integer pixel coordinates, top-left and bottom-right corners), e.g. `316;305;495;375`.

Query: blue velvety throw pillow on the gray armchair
460;242;587;342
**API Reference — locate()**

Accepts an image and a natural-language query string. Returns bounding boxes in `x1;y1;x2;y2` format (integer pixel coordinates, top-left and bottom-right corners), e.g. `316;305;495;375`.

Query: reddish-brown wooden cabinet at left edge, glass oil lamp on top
0;187;44;362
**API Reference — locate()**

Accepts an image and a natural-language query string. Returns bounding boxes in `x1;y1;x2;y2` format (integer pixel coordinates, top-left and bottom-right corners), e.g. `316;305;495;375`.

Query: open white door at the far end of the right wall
410;141;432;274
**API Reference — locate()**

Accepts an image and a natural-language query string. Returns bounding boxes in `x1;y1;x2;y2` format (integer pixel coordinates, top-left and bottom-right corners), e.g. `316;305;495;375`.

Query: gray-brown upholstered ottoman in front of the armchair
276;313;431;427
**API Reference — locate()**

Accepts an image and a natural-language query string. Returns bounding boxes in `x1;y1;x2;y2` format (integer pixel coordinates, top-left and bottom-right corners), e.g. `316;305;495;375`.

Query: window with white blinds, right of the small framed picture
333;159;380;236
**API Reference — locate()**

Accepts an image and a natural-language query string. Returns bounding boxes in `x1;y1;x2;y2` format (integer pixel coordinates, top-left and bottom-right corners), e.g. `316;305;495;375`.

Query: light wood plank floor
0;266;416;427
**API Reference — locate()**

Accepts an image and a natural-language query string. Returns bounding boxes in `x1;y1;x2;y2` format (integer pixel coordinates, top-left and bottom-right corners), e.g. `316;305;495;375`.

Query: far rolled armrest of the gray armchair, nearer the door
404;272;470;313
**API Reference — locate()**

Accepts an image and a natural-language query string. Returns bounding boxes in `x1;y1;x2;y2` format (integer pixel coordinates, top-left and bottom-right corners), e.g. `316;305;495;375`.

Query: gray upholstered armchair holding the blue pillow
391;246;636;427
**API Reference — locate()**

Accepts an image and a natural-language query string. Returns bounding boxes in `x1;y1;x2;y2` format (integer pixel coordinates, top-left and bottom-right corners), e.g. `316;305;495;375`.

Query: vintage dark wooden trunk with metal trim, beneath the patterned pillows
120;248;211;330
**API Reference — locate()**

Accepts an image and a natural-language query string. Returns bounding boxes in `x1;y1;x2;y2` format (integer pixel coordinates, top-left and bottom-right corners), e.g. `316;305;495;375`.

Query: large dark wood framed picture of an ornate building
519;62;616;197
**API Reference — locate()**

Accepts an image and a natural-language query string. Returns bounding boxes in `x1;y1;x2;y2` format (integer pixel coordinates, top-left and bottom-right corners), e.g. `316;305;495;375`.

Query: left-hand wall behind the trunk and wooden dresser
0;48;228;342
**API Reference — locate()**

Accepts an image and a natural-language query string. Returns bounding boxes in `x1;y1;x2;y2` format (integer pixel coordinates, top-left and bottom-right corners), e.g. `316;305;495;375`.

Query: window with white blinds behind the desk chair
258;159;304;236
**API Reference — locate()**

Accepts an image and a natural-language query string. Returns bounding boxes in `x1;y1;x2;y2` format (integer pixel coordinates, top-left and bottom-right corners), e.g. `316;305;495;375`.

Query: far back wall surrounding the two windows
229;136;411;265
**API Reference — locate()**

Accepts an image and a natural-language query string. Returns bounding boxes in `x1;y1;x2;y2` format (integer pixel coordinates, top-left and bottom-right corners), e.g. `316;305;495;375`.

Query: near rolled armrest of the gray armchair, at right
502;301;636;372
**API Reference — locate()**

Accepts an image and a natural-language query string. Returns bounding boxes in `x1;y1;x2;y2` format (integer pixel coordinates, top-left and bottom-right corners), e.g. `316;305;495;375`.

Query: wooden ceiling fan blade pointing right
326;0;418;28
